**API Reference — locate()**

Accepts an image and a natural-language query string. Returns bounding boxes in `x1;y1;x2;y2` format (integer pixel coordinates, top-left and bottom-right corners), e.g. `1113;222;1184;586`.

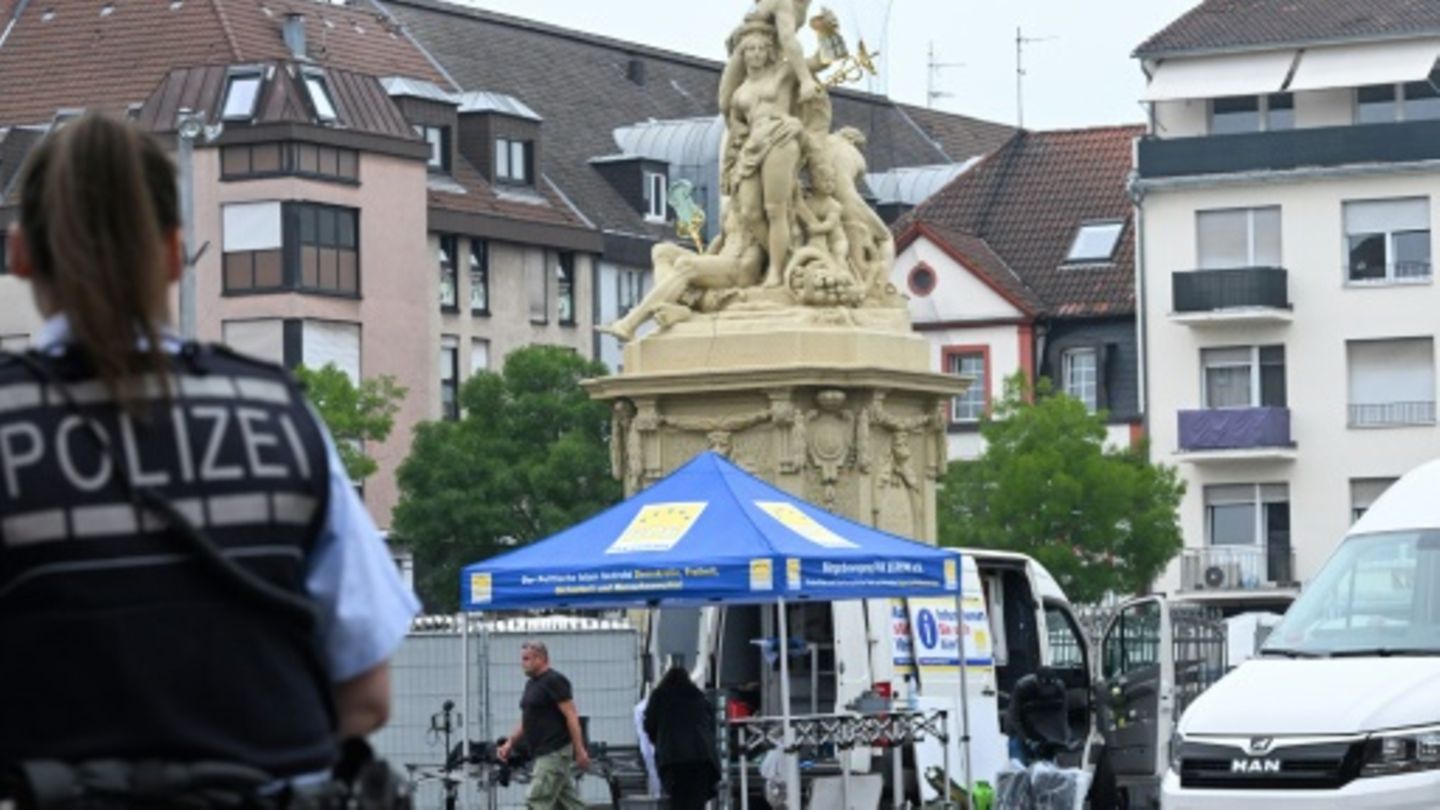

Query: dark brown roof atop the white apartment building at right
1135;0;1440;56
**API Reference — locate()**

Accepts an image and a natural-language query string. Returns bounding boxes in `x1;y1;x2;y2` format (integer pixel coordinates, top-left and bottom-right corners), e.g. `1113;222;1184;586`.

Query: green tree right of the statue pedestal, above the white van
937;375;1185;602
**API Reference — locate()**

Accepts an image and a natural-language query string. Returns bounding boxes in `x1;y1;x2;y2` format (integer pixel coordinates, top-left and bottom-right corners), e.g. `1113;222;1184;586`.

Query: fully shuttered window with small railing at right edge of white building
1345;337;1436;428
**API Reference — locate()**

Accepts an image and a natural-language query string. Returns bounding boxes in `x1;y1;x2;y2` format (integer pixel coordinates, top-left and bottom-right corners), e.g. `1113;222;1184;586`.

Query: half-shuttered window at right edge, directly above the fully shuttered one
1345;197;1431;284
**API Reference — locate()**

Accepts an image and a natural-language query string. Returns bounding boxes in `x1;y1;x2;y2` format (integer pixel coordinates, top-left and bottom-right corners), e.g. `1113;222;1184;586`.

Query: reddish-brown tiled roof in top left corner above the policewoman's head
0;0;445;124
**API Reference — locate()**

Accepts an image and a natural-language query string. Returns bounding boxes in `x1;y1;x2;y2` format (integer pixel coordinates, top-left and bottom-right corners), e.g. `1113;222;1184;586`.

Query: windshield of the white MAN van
1261;530;1440;657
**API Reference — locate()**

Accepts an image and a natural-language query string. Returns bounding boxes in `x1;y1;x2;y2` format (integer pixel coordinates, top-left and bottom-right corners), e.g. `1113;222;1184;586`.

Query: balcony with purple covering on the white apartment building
1179;408;1295;463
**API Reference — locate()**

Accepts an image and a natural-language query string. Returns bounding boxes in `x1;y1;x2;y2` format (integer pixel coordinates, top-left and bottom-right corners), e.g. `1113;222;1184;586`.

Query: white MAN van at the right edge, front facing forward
1162;461;1440;810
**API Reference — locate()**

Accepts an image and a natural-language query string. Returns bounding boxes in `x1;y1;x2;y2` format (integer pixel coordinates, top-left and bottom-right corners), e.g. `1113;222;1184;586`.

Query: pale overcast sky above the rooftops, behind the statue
462;0;1198;128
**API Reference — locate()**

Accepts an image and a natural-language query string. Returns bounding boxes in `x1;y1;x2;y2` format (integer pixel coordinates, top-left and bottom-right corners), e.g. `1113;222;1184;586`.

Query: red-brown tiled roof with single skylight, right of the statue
896;127;1145;317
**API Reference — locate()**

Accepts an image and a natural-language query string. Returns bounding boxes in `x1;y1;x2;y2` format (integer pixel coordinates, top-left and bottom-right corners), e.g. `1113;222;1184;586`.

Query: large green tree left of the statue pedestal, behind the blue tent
395;346;621;611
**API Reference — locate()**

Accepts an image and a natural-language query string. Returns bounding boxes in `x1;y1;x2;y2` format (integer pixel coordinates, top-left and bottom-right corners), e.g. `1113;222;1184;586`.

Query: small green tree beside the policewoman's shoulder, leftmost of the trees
295;363;408;483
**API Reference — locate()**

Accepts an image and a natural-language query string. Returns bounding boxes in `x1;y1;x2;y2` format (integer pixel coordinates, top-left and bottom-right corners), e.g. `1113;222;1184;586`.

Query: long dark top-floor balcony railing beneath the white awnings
1138;121;1440;180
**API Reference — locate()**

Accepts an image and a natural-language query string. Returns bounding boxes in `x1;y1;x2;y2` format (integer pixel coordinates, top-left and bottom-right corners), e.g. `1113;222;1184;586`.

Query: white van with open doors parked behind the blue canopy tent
647;549;1092;797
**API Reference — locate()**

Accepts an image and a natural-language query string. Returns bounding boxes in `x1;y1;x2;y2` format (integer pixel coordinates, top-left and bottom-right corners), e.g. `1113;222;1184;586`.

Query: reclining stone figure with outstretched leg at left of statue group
599;205;765;340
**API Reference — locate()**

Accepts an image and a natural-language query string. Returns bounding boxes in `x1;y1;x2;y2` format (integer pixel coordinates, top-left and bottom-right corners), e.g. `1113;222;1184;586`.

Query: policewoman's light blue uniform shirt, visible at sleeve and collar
35;316;420;683
